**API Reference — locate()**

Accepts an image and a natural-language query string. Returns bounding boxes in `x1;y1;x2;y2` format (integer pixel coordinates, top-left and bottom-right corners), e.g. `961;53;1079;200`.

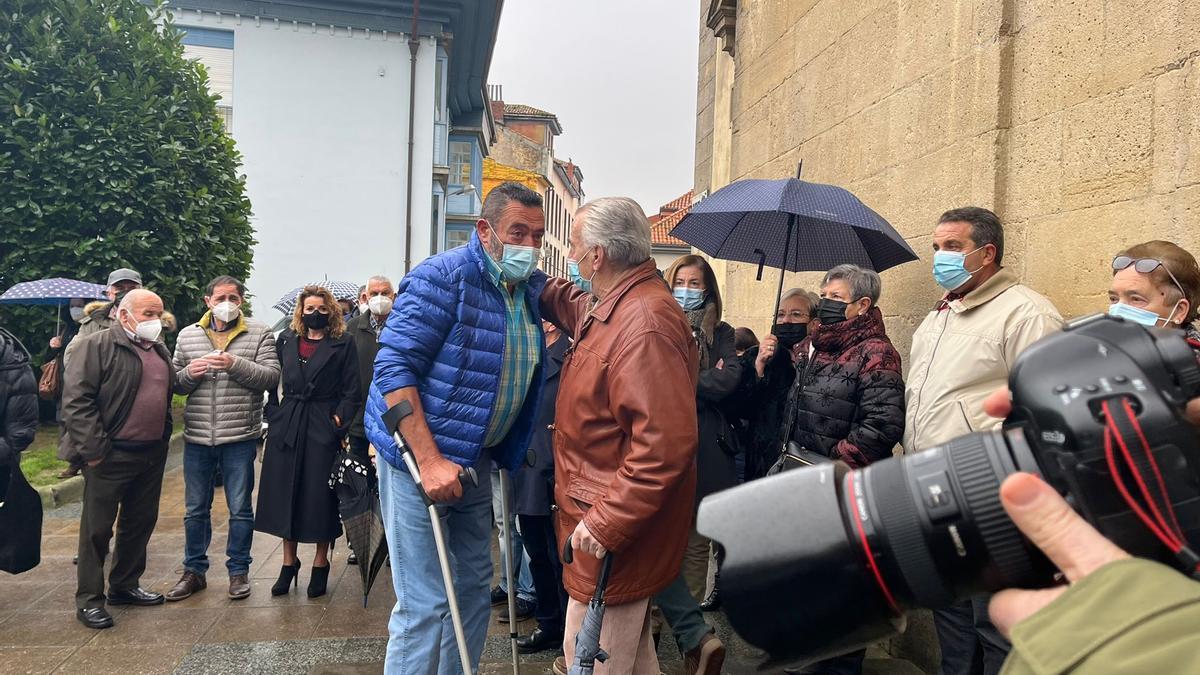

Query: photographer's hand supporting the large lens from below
988;473;1129;638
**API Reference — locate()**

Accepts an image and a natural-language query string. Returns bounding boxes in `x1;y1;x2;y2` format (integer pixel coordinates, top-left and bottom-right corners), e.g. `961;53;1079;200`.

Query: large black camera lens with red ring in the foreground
698;430;1052;662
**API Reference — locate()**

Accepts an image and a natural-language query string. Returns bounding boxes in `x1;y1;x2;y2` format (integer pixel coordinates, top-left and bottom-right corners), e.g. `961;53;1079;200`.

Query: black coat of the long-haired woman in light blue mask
696;322;742;503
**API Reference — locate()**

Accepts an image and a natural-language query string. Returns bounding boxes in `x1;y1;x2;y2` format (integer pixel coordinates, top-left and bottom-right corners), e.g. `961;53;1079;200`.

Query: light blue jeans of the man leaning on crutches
378;453;492;675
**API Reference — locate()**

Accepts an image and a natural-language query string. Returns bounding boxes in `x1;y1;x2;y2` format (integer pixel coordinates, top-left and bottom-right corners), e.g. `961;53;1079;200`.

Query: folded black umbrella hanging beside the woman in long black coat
329;450;388;607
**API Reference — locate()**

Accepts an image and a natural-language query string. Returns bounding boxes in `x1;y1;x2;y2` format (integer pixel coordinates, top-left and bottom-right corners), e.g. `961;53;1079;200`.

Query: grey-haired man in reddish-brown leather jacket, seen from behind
541;198;698;675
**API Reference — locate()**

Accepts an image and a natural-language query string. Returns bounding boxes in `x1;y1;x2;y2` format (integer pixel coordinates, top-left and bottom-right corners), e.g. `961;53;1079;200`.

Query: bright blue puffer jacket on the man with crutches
364;234;546;471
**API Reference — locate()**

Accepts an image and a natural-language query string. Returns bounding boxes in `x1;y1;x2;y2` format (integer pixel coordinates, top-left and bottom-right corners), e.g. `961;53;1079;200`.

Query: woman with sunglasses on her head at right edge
1109;240;1200;346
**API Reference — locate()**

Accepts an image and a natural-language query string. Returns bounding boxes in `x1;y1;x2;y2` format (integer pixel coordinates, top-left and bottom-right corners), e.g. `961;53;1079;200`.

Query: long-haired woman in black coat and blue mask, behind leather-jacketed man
664;256;742;602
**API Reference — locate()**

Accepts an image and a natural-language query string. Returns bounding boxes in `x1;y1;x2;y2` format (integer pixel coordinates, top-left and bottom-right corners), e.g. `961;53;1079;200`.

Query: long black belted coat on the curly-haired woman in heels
254;329;360;543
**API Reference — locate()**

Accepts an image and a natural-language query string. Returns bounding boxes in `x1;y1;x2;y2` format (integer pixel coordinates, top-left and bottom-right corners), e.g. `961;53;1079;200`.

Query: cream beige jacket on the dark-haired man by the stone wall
904;269;1062;453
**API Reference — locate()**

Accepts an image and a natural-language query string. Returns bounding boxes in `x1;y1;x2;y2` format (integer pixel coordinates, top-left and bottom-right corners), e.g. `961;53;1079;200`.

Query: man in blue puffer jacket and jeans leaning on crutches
364;183;546;675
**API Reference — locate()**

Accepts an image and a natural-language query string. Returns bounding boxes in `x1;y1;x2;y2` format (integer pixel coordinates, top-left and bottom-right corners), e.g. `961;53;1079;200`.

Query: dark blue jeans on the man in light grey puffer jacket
184;440;258;577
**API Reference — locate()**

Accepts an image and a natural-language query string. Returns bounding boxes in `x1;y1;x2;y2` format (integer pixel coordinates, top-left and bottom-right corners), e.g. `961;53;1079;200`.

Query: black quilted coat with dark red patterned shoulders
785;307;905;468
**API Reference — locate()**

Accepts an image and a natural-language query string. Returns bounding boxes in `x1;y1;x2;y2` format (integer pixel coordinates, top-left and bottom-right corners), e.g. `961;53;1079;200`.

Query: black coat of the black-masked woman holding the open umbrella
725;346;796;480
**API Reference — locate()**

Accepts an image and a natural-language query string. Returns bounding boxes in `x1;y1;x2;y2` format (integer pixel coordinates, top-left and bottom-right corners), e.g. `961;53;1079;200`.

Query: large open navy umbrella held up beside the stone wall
671;165;917;312
